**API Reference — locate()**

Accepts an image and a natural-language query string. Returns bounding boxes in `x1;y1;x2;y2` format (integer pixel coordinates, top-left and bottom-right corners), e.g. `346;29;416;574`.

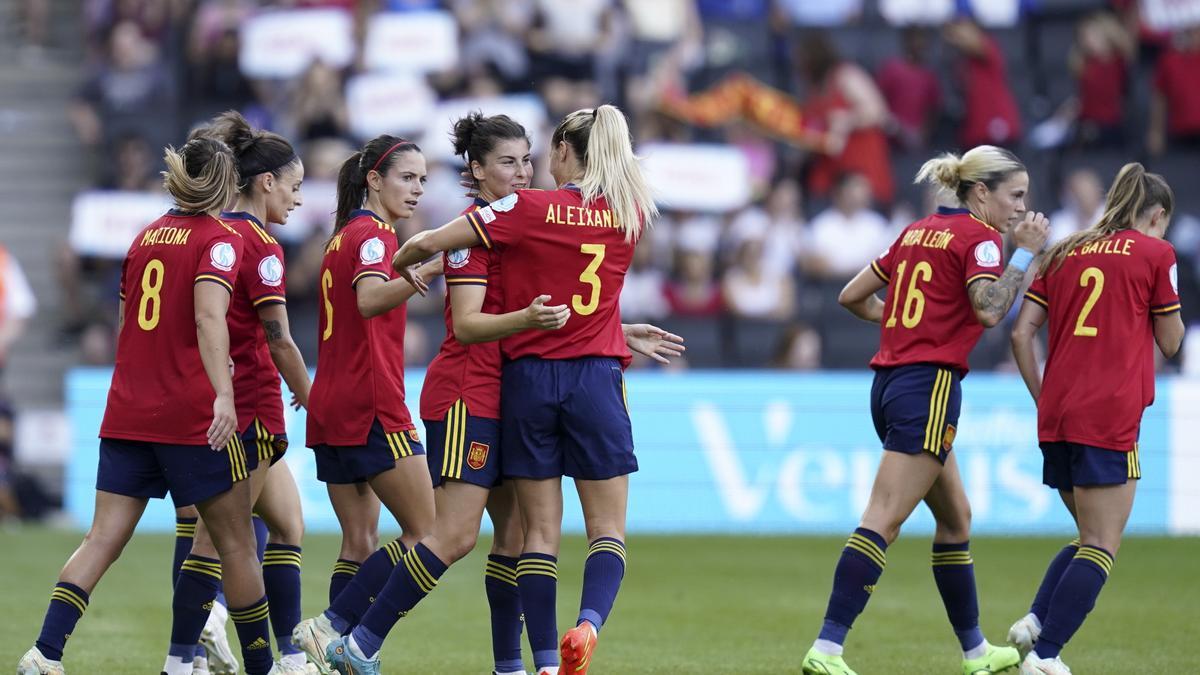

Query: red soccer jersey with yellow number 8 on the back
100;210;242;446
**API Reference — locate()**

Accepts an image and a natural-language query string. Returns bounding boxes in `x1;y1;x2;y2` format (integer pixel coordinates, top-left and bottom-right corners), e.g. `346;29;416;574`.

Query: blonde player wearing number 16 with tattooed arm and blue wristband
803;145;1046;675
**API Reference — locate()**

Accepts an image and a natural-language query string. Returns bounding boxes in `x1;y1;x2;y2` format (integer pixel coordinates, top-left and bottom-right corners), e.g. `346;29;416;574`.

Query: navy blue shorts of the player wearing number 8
96;436;258;507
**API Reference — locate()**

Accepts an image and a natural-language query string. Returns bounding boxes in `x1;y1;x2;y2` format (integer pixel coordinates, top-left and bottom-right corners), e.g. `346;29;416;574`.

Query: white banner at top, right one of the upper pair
362;12;458;73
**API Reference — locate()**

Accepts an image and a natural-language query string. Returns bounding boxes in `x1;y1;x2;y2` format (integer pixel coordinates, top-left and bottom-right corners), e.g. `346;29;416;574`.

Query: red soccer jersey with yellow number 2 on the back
1025;229;1180;452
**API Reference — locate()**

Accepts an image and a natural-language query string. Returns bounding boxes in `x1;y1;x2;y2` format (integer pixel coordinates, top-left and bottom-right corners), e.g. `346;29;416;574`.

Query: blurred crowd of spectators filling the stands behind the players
42;0;1200;369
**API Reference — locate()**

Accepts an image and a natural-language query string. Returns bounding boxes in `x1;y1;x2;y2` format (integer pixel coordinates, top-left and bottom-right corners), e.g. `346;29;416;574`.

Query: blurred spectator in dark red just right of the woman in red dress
876;25;942;150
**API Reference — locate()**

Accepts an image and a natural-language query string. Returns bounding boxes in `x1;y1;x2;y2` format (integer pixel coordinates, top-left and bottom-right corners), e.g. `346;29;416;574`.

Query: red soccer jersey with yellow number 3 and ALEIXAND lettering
467;185;634;366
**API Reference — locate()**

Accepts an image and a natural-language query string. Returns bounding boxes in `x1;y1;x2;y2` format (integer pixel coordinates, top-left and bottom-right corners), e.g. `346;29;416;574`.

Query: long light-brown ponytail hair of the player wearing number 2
1040;162;1175;274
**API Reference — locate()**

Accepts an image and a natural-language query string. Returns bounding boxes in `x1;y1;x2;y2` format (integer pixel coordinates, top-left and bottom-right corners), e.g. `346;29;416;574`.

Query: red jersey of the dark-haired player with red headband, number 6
306;209;416;447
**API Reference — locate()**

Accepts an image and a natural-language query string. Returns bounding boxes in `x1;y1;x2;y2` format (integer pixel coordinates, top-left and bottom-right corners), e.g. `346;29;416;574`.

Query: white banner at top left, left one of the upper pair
238;10;355;79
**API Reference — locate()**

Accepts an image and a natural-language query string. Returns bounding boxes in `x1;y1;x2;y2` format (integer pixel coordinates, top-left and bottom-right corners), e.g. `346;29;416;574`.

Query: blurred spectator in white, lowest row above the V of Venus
721;237;796;321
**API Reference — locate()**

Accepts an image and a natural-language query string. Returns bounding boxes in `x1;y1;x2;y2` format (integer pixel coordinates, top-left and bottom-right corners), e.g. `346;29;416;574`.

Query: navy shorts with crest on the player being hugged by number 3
421;401;500;490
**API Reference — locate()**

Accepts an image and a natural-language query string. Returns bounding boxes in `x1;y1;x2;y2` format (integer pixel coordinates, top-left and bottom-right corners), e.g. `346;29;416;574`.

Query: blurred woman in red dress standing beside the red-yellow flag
799;32;895;204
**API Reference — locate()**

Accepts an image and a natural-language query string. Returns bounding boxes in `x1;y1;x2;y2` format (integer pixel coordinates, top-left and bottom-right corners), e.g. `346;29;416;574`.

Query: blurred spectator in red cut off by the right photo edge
1146;26;1200;155
